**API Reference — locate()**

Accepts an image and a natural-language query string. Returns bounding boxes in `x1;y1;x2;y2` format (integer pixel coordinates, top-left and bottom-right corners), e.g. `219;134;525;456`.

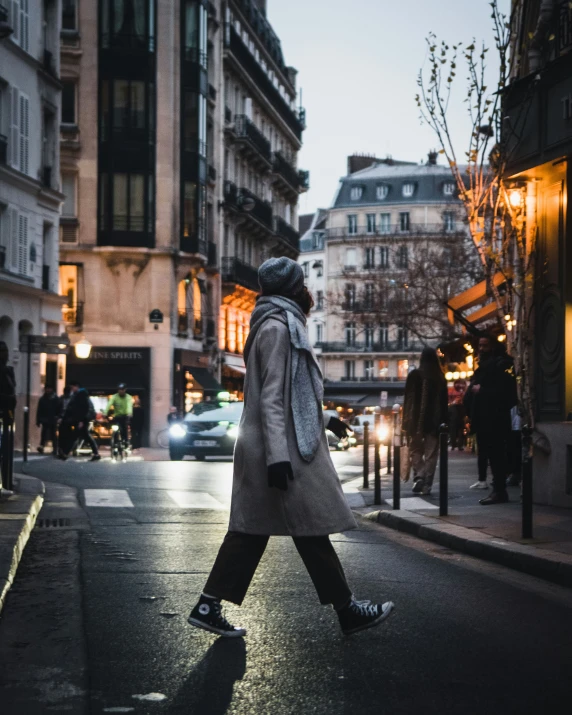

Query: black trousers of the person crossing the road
204;531;352;609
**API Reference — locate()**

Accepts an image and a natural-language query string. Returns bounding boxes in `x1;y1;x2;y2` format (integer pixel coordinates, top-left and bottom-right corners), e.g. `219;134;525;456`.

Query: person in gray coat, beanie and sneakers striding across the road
189;257;393;637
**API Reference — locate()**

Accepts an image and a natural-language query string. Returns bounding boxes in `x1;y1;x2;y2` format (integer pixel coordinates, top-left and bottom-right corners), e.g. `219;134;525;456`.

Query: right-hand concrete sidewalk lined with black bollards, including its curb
344;452;572;587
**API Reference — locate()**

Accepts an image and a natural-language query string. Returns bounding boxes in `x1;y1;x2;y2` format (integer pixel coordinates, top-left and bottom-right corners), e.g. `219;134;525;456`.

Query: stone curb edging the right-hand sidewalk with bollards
354;510;572;588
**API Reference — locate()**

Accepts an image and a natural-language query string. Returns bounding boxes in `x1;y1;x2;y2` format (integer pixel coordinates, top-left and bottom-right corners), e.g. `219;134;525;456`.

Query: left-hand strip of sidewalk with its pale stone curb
0;474;45;613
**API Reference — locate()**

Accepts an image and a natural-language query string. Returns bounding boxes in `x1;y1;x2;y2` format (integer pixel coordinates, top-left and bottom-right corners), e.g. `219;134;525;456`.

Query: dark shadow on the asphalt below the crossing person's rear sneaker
173;638;246;715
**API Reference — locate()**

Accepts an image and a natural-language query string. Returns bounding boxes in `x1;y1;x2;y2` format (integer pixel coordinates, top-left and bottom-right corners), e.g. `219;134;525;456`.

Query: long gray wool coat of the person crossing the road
229;316;357;536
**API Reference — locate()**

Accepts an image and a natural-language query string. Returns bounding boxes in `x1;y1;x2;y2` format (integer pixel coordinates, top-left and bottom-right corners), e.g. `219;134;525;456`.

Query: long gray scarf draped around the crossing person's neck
244;295;324;462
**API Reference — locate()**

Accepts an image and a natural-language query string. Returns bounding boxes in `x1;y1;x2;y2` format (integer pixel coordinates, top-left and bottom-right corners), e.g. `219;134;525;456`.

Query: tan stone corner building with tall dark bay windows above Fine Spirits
60;0;301;444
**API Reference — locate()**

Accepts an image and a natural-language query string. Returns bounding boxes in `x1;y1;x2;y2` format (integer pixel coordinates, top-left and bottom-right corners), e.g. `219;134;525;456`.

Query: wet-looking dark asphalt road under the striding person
0;452;572;715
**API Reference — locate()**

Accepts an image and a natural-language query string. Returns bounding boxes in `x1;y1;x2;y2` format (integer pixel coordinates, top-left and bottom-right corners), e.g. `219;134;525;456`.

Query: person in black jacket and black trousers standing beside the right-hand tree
464;335;516;506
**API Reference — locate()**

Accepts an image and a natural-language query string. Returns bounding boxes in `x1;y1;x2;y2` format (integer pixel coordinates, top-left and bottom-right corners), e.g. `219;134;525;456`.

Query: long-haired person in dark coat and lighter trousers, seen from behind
403;347;448;496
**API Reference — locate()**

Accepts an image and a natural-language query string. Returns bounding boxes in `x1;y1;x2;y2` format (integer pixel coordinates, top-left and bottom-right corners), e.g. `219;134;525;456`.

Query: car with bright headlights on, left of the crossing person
169;401;244;462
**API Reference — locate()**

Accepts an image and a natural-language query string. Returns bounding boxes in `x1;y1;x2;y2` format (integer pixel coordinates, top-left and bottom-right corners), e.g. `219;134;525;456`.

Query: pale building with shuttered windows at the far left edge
0;0;65;447
